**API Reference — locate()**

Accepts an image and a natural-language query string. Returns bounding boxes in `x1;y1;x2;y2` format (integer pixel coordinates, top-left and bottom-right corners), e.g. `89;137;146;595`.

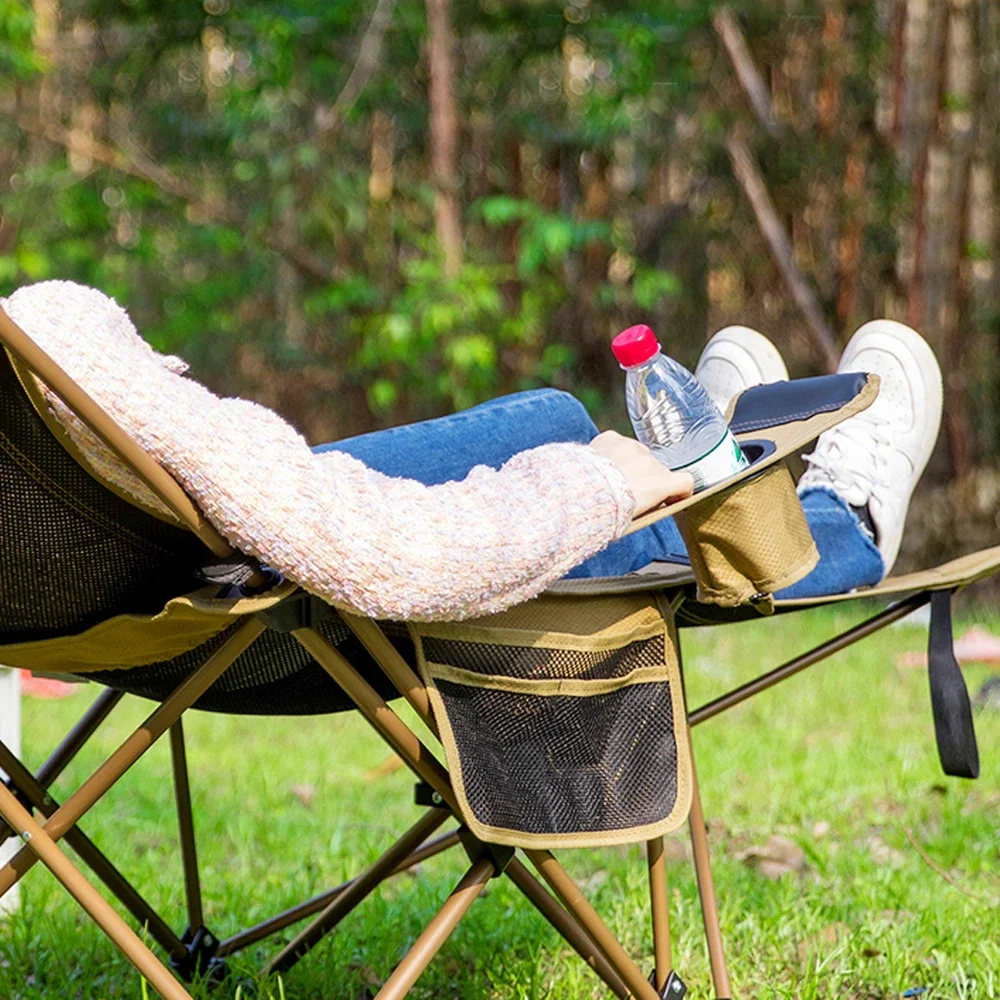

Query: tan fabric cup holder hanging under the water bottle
677;462;819;614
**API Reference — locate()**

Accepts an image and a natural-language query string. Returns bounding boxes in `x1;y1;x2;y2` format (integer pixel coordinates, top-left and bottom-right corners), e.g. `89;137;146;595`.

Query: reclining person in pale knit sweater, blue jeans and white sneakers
0;281;942;620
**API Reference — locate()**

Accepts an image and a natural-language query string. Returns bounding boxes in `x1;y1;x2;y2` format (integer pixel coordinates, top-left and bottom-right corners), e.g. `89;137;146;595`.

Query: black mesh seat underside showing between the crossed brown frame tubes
86;617;414;715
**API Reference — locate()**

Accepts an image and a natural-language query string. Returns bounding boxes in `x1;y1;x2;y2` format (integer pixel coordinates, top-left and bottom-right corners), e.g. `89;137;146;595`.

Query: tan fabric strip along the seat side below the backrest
0;581;297;674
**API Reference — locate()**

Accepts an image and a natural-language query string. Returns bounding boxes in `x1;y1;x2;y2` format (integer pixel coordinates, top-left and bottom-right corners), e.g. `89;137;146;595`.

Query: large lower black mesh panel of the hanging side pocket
437;681;677;835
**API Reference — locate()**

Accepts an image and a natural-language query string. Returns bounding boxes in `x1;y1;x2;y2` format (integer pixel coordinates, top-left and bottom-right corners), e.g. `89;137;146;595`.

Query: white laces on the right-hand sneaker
802;413;893;507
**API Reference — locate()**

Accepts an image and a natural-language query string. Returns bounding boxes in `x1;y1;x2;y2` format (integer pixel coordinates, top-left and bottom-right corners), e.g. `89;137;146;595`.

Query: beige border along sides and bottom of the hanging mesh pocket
407;601;692;850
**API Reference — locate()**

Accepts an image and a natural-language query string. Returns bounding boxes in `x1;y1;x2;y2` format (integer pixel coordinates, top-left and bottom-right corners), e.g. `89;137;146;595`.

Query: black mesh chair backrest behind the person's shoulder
0;322;211;644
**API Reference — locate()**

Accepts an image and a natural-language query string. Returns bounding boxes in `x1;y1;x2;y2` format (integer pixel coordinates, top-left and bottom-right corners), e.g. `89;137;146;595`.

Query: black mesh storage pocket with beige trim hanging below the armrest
410;594;691;848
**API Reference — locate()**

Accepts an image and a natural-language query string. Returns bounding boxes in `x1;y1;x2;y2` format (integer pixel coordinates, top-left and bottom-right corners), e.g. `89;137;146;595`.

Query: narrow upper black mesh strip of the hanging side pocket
423;636;663;680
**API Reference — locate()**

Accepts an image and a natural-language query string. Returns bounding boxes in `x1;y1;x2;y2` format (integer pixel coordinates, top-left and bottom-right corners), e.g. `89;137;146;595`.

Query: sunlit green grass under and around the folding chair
0;608;1000;1000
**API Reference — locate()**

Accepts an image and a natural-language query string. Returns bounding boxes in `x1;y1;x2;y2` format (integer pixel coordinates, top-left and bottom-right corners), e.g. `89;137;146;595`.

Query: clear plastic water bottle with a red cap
611;326;750;493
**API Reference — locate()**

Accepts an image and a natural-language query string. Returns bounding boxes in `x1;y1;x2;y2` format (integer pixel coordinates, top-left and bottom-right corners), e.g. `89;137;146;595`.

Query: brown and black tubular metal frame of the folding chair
0;310;964;1000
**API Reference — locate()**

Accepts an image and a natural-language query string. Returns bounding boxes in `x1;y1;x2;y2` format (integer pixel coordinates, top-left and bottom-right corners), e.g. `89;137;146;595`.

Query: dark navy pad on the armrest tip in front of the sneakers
729;372;868;434
